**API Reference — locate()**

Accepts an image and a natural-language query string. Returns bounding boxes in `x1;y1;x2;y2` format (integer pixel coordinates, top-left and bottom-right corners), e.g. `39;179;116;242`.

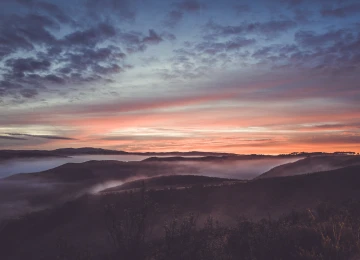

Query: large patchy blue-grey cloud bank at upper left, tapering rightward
0;0;166;102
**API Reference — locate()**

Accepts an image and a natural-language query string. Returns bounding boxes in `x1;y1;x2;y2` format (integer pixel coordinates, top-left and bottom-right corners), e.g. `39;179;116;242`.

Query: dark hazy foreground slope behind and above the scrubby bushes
0;166;360;260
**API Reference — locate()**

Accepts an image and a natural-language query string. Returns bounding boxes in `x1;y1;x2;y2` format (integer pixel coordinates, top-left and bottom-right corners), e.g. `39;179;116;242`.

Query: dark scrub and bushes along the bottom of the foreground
58;187;360;260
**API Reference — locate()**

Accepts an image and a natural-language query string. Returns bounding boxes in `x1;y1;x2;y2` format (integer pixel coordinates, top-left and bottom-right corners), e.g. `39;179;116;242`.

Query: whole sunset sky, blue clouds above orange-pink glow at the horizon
0;0;360;154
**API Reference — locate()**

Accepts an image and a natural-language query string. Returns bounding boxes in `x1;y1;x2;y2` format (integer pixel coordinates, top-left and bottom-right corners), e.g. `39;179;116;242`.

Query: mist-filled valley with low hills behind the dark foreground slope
0;157;294;219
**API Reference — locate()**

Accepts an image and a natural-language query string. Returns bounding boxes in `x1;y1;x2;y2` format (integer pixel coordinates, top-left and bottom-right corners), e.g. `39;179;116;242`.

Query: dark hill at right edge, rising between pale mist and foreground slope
257;155;360;179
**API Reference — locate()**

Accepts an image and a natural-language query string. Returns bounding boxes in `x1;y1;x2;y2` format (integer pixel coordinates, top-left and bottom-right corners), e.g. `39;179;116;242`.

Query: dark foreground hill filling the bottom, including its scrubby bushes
0;166;360;260
